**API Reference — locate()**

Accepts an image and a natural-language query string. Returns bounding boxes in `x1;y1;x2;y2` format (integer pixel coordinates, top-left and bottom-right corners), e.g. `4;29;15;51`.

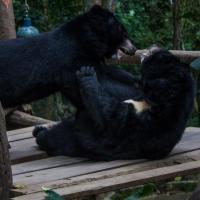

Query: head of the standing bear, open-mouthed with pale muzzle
65;5;136;60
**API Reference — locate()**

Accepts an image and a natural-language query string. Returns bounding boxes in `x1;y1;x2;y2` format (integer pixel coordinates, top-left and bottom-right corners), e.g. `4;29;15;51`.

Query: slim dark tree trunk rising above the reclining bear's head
172;0;181;50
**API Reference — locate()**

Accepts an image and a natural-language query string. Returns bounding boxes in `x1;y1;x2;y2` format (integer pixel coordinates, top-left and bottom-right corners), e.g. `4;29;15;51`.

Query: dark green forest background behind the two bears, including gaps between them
13;0;200;126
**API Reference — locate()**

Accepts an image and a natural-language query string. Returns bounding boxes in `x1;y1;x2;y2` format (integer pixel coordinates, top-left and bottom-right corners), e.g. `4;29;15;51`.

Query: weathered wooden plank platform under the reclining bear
8;128;200;200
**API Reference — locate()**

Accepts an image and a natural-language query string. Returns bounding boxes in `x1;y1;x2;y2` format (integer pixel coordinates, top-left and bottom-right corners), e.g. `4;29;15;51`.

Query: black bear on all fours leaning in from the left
0;6;137;107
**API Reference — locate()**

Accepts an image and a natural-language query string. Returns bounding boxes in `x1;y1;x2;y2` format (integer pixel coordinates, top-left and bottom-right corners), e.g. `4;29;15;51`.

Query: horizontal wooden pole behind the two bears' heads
108;50;200;65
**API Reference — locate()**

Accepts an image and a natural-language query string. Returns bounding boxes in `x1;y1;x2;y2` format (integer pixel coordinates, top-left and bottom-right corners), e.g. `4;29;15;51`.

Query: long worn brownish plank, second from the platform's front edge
14;150;200;194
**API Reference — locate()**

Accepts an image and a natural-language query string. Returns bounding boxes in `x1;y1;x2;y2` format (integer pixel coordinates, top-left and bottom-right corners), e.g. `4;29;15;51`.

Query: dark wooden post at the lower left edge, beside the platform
0;103;12;200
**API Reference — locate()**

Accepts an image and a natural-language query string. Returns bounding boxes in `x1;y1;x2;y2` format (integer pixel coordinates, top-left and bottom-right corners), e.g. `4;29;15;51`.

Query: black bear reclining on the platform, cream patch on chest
33;48;194;160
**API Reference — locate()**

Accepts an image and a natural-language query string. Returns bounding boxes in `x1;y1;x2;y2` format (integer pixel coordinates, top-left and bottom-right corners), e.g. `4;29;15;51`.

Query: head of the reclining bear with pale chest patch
141;46;193;105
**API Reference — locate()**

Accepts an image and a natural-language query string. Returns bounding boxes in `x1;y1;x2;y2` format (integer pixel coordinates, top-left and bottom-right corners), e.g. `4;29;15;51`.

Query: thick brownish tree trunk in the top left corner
0;0;16;39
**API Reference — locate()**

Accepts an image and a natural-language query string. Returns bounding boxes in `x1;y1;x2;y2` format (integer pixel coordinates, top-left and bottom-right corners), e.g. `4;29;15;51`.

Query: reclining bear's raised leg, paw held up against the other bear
76;67;118;129
